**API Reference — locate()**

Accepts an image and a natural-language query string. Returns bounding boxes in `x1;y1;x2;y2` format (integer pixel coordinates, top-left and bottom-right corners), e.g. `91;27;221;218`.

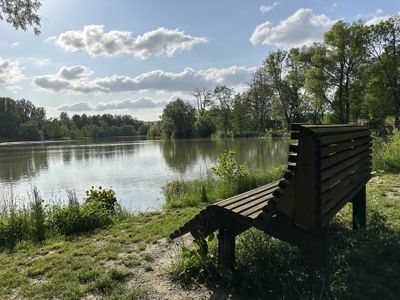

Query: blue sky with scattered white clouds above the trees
0;0;400;121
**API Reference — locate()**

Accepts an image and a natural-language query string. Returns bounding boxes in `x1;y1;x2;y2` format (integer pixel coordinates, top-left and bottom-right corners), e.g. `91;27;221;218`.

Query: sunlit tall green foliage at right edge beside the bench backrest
372;130;400;172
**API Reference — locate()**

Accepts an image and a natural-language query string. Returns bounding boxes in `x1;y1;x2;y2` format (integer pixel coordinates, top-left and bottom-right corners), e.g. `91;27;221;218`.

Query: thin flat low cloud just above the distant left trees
57;97;167;112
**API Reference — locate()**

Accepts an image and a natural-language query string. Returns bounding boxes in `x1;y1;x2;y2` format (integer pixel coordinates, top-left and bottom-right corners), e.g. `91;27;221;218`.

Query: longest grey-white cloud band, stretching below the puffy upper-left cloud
33;66;256;93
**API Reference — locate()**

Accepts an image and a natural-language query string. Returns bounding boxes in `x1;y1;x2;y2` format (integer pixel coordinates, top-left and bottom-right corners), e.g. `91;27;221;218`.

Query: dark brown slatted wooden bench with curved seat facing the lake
171;124;372;294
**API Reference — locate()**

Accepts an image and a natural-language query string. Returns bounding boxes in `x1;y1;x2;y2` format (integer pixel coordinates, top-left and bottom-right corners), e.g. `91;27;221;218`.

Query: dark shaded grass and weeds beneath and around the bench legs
170;211;400;299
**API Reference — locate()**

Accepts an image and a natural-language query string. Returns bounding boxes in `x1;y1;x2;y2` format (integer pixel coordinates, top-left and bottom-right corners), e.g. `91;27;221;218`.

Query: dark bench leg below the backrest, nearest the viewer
307;225;332;299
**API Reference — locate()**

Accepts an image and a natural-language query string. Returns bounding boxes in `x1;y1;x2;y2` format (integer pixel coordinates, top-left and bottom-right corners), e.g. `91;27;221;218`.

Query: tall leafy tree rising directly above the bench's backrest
303;21;366;123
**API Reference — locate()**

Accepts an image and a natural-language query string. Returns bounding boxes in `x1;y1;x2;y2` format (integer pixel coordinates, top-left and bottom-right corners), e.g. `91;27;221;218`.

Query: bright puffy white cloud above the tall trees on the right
250;8;336;48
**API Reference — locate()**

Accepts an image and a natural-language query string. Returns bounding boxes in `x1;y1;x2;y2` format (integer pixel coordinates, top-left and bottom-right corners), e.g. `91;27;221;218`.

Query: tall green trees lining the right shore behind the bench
148;15;400;138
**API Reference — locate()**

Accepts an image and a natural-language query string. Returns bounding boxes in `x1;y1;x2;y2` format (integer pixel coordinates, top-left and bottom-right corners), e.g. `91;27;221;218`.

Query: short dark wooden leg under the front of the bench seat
218;226;235;269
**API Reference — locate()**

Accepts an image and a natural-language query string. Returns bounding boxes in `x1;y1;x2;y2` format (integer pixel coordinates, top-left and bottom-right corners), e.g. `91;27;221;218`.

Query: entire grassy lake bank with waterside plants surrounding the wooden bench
0;136;400;299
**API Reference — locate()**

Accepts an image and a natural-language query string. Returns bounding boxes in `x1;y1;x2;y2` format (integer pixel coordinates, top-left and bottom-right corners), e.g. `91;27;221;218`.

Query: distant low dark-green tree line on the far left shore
0;97;148;141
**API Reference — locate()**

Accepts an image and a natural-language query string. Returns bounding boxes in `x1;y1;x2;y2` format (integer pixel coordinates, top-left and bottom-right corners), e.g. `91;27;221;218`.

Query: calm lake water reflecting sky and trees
0;138;287;211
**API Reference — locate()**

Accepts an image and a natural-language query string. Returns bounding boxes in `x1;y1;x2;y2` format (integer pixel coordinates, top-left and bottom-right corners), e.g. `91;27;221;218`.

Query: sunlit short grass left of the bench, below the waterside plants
0;208;197;299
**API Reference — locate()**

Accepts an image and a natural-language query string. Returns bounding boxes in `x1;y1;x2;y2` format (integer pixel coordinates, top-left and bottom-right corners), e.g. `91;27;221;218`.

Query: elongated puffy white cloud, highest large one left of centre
56;25;207;59
